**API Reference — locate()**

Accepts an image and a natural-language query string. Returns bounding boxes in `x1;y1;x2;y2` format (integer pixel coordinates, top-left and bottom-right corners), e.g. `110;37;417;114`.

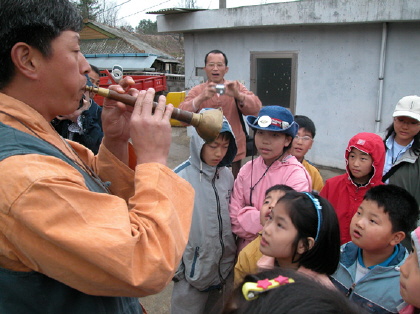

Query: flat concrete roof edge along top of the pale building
157;0;420;33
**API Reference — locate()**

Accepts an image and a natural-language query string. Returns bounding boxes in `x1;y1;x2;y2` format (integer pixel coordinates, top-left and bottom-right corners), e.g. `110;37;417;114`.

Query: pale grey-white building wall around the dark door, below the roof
181;23;420;169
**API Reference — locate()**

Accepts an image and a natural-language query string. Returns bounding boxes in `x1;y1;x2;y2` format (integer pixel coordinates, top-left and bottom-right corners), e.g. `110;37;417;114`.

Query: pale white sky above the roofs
113;0;293;27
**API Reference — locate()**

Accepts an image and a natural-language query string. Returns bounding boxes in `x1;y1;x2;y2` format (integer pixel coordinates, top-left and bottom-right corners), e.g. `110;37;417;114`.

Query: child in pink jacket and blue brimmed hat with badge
229;106;312;253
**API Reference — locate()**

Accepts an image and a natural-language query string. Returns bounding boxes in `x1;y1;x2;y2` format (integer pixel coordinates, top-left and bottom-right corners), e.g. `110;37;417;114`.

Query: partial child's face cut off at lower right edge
400;244;420;308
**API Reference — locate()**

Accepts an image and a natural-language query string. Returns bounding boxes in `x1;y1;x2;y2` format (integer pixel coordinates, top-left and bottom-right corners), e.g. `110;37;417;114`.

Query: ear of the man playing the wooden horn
11;42;42;79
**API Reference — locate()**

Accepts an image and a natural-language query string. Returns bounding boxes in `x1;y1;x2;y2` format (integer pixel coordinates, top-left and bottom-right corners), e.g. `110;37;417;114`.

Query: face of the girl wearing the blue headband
260;202;298;267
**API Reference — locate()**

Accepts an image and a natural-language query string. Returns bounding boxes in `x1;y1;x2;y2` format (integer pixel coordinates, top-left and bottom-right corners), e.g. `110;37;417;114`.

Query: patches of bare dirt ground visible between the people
140;127;344;314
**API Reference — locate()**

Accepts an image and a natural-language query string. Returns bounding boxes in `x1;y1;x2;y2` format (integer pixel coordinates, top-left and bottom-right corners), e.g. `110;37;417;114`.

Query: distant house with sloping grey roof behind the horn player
80;21;180;74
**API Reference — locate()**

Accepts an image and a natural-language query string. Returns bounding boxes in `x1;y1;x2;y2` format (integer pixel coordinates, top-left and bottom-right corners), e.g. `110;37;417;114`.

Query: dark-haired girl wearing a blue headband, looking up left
235;192;340;287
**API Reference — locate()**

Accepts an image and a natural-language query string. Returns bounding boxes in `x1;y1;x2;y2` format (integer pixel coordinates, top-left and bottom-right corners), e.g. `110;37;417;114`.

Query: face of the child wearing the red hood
349;147;373;184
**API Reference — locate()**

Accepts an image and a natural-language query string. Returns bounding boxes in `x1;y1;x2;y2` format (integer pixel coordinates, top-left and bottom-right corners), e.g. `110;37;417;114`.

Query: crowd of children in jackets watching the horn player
171;96;420;313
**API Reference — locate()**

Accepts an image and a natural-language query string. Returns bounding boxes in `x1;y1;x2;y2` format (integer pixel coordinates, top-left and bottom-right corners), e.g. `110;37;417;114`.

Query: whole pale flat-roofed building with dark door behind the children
157;0;420;169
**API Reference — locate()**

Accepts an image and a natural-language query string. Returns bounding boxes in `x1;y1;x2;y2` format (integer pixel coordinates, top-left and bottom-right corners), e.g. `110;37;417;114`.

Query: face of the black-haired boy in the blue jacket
350;200;395;252
